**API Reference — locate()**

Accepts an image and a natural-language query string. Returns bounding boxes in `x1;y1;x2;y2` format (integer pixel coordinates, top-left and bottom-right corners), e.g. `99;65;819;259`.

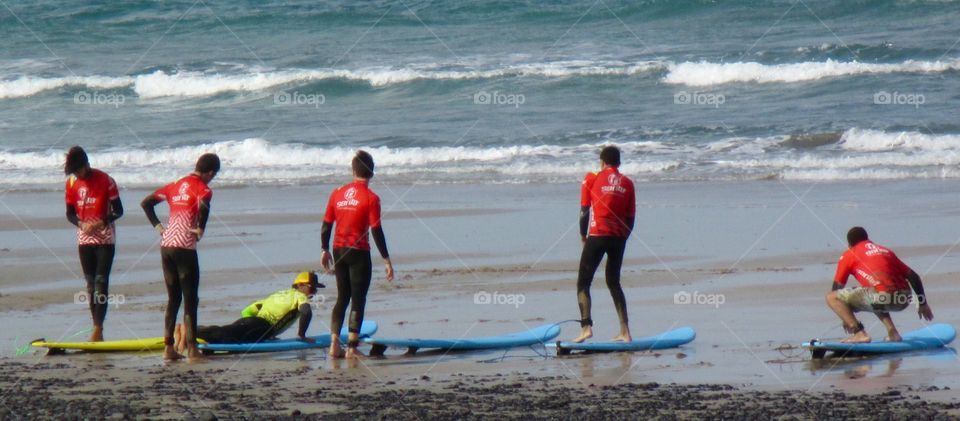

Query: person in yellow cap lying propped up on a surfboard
174;272;320;352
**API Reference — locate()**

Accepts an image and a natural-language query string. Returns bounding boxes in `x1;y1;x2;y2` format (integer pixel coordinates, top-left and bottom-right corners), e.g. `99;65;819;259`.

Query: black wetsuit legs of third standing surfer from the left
330;248;373;333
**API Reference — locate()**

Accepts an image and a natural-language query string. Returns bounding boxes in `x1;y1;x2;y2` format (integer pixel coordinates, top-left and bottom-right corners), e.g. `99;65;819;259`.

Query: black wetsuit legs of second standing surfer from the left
160;247;200;344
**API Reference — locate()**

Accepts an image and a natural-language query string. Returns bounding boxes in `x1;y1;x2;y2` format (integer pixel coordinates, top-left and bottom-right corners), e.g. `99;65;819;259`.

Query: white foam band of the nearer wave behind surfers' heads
0;128;960;188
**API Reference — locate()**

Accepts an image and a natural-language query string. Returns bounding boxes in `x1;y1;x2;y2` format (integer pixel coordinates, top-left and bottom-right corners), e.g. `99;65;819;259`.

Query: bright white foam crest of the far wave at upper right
663;60;960;86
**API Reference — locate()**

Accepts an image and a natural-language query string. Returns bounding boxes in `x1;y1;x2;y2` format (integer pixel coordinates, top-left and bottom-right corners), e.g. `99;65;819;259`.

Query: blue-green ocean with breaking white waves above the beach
0;0;960;190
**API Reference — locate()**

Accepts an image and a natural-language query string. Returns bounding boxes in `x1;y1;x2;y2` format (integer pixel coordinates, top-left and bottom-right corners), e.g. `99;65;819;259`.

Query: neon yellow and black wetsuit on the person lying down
197;288;313;343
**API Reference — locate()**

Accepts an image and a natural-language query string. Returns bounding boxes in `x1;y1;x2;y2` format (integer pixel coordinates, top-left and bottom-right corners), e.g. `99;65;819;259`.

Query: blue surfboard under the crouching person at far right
801;323;957;358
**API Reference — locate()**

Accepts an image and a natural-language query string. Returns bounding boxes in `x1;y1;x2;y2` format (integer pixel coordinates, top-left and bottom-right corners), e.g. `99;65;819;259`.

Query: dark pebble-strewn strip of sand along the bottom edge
0;361;960;420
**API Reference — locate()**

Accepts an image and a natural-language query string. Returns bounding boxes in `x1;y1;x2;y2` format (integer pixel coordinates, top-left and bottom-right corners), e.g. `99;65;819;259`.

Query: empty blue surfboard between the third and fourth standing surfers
364;324;560;355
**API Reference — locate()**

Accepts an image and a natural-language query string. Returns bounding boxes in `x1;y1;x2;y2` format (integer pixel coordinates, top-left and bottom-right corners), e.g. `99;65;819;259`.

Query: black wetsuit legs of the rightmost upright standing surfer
577;237;627;326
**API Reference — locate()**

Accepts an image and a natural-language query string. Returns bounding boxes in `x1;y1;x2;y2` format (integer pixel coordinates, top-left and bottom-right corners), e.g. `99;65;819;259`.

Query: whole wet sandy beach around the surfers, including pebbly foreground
0;181;960;419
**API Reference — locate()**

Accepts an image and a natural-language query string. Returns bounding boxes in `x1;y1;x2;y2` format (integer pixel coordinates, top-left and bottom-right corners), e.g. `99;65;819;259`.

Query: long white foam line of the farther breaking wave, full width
0;60;960;99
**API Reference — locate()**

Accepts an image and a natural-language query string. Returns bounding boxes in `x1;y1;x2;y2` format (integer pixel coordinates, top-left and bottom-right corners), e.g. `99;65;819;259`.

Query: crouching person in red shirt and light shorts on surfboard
827;227;933;343
